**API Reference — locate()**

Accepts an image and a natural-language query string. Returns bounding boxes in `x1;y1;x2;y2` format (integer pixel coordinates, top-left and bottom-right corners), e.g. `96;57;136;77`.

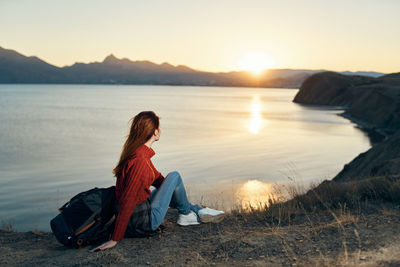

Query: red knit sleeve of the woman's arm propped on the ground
111;158;147;241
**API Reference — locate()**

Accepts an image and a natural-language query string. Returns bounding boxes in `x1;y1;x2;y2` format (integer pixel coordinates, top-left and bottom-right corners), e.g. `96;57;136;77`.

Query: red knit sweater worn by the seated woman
111;145;164;241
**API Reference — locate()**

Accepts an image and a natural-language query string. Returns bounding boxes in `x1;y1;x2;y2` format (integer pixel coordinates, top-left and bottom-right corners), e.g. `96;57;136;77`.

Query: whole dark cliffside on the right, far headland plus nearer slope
293;72;400;181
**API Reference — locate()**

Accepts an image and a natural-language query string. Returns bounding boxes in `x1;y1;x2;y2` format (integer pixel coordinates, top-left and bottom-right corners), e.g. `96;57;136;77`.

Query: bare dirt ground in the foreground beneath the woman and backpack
0;210;400;266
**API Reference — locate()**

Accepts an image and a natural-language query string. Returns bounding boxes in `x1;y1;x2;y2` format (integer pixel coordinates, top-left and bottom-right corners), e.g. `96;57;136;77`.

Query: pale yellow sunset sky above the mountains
0;0;400;72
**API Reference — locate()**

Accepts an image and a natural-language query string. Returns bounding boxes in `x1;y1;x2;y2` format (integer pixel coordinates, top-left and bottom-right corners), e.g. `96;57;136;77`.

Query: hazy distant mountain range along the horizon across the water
0;47;384;88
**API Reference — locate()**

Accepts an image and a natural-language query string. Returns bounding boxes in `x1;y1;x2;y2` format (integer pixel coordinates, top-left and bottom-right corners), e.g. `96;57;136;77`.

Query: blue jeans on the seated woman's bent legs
150;171;201;230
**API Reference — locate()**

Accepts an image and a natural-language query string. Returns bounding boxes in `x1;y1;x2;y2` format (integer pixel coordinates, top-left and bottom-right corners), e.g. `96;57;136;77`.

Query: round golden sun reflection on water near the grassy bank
236;180;282;209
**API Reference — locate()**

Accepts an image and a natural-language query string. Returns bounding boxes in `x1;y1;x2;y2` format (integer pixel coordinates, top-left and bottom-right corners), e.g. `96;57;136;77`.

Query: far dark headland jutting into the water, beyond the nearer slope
293;72;400;134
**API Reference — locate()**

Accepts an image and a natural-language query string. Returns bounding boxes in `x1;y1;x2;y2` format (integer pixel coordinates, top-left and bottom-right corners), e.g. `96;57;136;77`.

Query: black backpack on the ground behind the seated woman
50;186;115;248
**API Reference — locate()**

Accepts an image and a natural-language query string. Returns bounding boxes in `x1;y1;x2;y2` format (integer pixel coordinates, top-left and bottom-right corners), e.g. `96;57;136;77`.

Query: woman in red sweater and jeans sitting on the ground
91;111;224;252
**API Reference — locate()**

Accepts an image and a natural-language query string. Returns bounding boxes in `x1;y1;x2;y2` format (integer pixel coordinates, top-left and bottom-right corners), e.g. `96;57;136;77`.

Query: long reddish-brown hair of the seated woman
113;111;160;177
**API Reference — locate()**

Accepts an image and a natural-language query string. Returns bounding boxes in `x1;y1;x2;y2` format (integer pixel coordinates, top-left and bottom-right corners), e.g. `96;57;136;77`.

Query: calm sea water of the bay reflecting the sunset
0;85;370;231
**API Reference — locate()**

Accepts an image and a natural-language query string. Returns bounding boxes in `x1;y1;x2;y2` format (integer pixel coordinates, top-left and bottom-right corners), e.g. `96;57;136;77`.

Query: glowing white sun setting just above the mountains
237;51;275;74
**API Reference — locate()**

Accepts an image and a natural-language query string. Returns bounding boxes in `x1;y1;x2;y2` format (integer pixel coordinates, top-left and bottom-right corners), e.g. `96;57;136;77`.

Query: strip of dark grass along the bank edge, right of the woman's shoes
232;176;400;226
